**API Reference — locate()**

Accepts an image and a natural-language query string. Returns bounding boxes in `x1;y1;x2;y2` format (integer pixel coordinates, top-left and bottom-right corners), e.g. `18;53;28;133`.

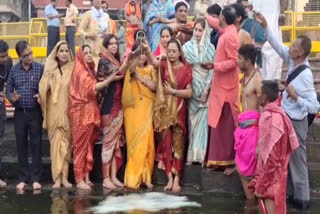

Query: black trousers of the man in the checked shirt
14;107;43;183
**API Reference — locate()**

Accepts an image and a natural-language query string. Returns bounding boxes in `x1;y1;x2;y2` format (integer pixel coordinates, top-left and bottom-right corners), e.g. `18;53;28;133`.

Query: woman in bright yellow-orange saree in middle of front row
122;44;156;189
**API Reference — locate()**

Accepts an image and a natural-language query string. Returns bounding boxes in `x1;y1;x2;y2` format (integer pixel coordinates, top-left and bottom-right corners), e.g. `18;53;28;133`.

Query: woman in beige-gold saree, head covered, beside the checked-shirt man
39;41;74;188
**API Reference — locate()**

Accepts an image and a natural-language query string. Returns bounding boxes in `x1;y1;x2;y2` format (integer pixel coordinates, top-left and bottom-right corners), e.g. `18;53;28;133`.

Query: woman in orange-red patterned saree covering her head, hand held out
69;45;117;189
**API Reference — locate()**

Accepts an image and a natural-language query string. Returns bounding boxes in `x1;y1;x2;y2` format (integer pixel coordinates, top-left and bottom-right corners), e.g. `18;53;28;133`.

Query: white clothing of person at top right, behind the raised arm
252;0;282;80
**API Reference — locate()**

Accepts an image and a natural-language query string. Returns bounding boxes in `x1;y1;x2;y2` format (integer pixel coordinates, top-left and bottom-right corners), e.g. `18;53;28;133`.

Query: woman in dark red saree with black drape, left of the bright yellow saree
98;34;130;189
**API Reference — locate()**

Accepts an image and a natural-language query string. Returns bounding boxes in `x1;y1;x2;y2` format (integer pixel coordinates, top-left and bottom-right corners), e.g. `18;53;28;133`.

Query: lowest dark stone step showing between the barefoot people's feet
2;157;320;194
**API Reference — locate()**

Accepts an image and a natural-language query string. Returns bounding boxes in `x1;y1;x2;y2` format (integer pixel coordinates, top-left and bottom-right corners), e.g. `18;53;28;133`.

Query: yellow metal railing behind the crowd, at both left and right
0;11;320;59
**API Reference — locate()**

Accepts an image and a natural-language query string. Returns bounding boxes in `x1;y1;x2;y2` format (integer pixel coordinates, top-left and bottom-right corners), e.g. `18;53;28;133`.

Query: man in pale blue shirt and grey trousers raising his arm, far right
255;13;320;209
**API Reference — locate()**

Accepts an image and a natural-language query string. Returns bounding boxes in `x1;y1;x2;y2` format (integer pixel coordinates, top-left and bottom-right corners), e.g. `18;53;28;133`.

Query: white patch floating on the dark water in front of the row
90;192;201;214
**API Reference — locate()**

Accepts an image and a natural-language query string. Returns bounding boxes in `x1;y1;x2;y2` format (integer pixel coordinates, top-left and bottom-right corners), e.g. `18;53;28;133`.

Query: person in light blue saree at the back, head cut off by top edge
144;0;175;53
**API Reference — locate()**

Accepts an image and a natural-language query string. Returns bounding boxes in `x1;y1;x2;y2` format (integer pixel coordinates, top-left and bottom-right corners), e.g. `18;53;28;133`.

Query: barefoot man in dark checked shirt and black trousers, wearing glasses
6;41;44;190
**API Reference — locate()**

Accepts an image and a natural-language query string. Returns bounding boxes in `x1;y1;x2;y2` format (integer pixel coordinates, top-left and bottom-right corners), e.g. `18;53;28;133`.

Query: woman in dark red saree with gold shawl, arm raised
144;39;192;192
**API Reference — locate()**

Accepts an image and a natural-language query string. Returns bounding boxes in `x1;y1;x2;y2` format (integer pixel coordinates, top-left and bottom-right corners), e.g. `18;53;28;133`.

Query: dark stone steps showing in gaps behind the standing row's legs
0;120;320;194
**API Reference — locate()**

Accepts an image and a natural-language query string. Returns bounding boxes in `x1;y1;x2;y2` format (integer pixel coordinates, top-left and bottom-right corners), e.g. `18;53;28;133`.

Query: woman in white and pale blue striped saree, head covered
183;19;215;165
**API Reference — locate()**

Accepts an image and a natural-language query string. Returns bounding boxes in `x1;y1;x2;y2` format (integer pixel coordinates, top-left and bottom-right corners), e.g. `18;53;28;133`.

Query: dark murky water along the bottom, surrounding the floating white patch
0;189;320;214
